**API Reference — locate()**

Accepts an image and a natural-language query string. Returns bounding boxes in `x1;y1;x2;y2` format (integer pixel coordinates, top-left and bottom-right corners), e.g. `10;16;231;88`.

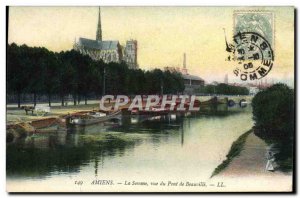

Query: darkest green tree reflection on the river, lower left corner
7;130;137;177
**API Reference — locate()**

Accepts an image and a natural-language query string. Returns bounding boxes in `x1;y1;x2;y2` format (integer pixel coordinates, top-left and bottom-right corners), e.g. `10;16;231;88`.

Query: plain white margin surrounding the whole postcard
0;0;300;197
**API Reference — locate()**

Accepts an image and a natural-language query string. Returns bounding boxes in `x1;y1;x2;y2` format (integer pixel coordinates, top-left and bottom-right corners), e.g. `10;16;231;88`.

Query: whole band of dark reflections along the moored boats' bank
7;105;250;178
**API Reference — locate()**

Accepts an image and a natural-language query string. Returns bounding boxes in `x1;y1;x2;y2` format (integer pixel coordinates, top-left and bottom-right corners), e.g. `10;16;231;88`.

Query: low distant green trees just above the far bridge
198;83;249;95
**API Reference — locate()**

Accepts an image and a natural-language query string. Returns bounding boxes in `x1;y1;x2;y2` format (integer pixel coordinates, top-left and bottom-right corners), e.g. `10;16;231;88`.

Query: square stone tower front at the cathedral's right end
124;40;138;69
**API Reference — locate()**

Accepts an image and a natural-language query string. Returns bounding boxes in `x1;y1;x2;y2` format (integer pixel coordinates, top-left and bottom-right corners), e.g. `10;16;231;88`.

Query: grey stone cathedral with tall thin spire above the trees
73;8;138;69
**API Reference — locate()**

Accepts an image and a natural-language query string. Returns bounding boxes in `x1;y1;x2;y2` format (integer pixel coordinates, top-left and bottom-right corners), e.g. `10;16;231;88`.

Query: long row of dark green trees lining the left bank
7;43;184;106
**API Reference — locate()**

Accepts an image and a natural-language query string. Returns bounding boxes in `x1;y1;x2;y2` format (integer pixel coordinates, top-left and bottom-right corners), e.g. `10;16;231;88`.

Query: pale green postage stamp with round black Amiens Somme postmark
226;11;275;81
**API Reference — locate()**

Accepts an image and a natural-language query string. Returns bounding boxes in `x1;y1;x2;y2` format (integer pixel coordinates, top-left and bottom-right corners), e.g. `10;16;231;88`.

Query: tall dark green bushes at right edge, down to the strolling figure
252;84;295;172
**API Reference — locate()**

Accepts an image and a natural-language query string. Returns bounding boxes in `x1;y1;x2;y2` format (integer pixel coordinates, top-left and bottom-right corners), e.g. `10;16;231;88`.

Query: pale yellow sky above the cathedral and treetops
8;7;294;84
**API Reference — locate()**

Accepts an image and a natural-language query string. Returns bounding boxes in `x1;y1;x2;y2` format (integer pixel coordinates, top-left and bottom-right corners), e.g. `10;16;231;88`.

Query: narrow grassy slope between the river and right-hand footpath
210;129;253;178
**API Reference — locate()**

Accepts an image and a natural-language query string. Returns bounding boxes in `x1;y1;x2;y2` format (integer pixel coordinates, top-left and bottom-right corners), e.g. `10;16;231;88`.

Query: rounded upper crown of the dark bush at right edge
252;84;295;139
